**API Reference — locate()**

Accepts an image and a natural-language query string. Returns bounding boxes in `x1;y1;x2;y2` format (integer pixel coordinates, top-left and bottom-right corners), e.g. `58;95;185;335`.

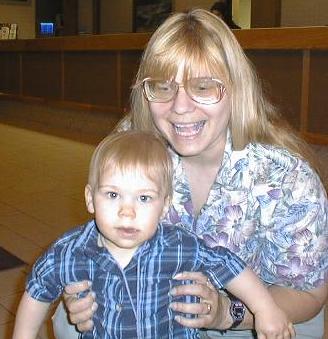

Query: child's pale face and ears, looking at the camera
85;170;168;258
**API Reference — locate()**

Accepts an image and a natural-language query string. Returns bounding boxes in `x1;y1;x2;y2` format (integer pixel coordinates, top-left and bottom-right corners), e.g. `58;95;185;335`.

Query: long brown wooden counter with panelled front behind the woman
0;27;328;144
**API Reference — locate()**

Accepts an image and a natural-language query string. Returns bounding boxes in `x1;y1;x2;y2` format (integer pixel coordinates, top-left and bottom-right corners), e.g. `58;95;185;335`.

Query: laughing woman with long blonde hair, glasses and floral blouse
54;9;328;339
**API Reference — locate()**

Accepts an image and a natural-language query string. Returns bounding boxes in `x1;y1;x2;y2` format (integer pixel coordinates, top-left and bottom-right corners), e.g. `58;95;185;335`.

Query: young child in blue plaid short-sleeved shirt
13;131;294;339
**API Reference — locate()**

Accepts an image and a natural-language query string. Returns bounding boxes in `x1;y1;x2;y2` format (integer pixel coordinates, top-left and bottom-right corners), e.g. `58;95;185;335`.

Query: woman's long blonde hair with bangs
130;9;317;178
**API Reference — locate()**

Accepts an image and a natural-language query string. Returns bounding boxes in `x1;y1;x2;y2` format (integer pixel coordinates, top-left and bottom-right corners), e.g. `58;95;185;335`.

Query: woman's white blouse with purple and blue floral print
165;136;328;289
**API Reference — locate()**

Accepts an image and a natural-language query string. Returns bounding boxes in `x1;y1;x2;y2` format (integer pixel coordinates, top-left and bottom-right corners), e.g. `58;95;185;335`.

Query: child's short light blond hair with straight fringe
88;131;173;197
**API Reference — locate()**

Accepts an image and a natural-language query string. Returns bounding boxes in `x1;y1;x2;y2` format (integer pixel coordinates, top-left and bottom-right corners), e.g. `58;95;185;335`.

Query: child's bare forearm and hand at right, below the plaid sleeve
226;268;295;339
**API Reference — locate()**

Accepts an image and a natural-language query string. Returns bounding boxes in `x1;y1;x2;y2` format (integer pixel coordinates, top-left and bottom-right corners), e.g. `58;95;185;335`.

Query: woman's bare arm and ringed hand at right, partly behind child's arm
171;272;328;330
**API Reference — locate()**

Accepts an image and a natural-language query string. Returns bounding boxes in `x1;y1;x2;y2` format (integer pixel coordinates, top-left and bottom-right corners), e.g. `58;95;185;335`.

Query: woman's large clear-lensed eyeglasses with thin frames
141;77;225;105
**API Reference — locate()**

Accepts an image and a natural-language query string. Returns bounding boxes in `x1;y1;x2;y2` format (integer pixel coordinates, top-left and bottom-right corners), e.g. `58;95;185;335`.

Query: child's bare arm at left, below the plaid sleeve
13;291;50;339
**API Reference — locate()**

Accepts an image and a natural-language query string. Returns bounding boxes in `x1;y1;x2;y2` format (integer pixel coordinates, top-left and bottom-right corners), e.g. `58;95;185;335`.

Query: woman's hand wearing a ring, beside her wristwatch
170;272;232;330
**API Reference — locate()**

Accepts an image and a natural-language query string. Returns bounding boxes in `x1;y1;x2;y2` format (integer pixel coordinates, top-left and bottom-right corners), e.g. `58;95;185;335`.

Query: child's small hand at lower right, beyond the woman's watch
255;307;296;339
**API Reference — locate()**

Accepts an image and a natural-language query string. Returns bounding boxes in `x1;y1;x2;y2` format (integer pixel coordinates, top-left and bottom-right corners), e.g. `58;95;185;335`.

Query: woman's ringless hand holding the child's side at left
64;280;98;332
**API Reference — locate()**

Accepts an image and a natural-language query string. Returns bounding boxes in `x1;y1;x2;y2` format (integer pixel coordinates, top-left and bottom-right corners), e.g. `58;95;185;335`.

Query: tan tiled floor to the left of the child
0;124;328;339
